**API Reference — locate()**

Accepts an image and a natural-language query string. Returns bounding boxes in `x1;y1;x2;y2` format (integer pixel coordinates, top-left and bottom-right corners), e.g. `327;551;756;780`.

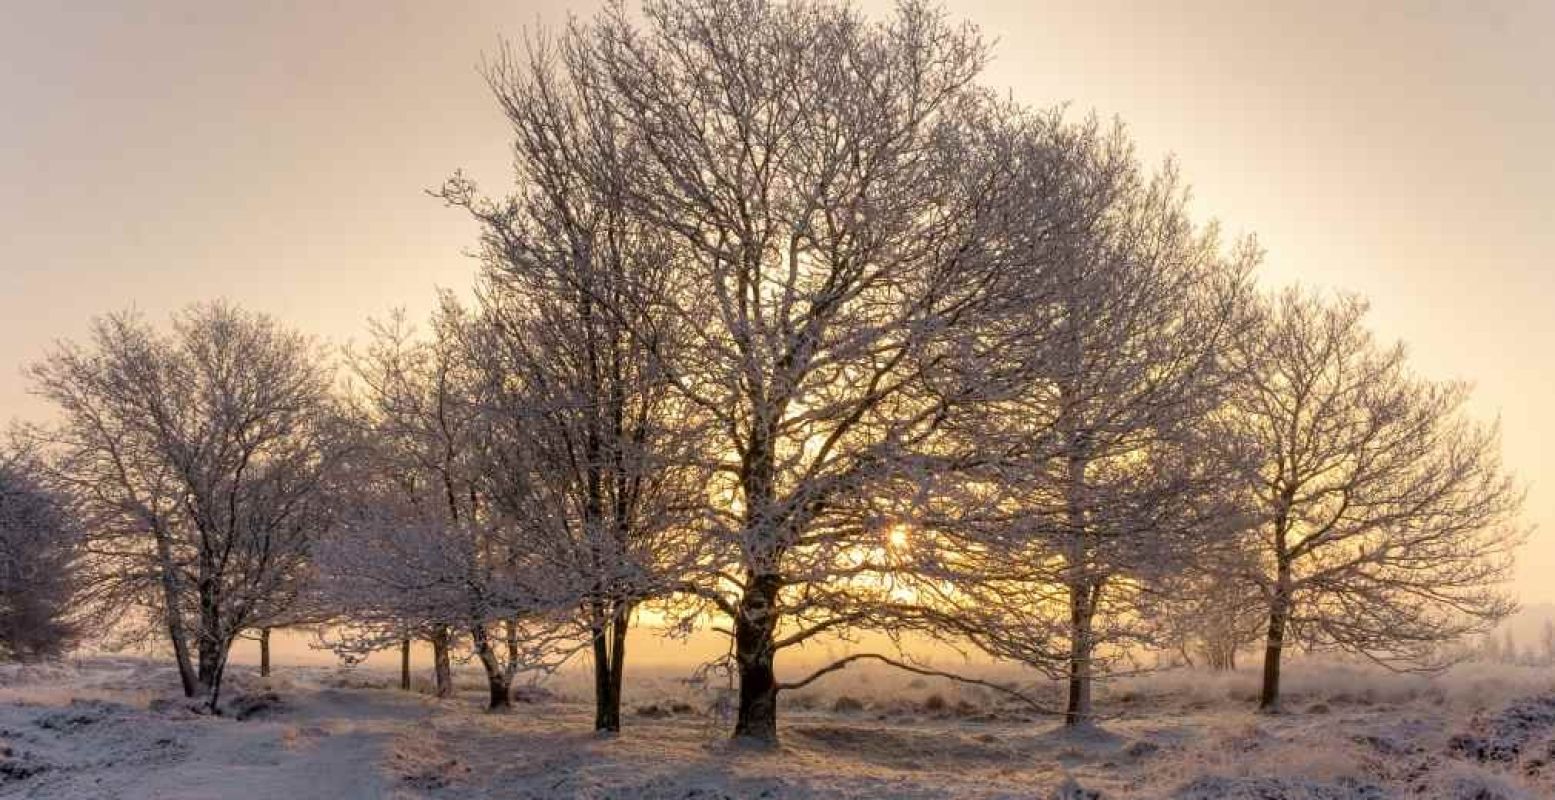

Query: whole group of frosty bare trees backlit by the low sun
5;0;1522;744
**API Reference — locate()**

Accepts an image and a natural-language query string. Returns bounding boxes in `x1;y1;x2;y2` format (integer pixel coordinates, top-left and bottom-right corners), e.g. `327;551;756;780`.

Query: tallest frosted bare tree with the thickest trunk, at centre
482;0;1032;742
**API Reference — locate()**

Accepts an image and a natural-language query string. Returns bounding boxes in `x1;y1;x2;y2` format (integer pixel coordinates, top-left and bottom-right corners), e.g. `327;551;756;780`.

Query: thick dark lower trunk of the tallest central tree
734;574;781;746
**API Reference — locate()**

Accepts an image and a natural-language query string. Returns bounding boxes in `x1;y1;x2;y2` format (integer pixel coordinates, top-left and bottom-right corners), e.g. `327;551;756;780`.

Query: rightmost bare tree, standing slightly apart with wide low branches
1224;289;1524;711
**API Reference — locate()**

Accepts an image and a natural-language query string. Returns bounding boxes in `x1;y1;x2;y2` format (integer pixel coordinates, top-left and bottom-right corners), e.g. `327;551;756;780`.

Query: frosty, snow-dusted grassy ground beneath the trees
0;657;1555;800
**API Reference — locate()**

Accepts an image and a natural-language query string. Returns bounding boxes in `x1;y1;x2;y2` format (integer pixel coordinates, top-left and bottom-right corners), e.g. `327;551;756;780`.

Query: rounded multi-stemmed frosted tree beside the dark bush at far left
30;302;341;711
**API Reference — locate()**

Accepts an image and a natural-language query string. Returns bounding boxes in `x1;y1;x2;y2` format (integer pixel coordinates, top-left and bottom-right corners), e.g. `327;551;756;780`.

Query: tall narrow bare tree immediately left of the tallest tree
442;31;721;732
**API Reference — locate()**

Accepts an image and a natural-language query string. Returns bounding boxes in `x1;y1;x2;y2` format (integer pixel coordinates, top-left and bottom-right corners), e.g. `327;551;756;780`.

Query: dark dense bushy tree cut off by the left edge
0;450;84;658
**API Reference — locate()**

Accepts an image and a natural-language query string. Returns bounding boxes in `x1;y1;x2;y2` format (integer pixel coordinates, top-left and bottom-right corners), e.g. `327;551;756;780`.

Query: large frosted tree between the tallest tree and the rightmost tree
924;117;1256;724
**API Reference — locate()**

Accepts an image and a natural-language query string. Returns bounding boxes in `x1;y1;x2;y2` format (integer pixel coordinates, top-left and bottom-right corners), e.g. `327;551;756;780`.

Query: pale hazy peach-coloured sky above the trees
0;0;1555;602
